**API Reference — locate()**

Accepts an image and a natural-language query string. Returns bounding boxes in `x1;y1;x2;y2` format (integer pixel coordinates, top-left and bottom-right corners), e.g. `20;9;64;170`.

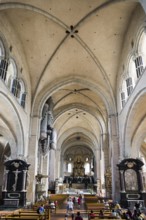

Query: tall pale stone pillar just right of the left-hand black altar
26;116;40;202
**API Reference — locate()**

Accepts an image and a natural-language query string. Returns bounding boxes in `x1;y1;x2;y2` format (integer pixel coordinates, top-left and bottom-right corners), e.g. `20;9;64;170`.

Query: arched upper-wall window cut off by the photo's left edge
0;40;8;81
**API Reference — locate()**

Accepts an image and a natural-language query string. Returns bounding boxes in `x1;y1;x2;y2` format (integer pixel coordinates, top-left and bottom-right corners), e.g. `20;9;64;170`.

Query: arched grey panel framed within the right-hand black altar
125;169;138;191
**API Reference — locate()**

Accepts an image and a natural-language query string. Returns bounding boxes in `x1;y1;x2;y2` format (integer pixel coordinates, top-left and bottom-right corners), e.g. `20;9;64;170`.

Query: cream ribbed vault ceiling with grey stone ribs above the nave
0;0;140;153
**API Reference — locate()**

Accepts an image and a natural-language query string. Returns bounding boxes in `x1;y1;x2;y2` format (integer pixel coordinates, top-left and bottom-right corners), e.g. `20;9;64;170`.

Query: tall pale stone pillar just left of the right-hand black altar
109;114;120;201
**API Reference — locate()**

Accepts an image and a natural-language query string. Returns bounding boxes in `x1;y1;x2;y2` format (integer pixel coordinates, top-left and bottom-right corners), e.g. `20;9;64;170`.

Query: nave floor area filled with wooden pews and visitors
0;194;146;220
